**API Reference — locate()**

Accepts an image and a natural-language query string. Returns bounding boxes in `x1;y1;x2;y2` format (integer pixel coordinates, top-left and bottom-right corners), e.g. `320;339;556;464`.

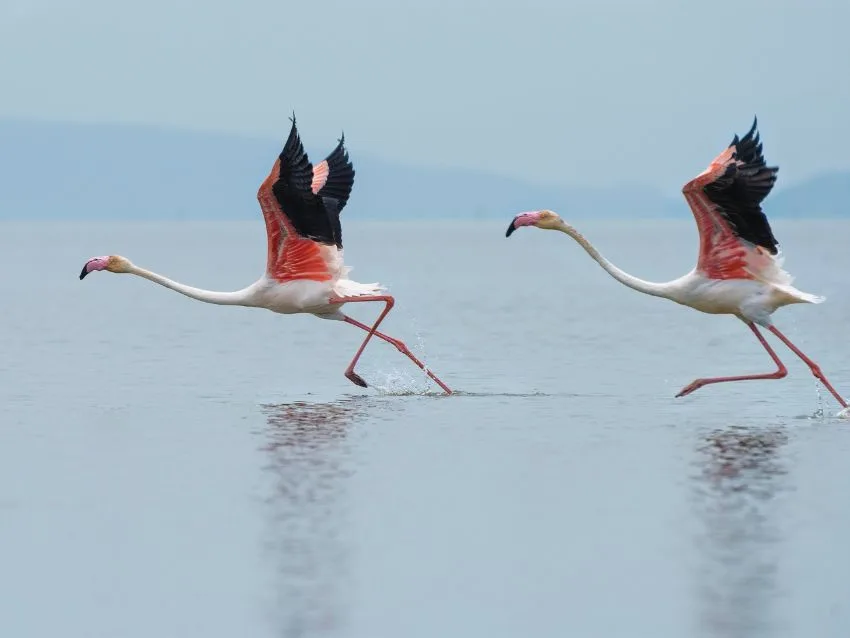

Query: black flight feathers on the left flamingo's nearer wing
272;116;353;249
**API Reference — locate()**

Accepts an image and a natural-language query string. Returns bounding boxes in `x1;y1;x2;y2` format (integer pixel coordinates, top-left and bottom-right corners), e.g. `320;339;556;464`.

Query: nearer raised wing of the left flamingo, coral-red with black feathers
257;117;352;281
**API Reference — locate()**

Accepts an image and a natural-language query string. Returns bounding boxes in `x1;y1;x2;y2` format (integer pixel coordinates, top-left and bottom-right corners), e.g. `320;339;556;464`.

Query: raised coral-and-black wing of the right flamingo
682;119;779;279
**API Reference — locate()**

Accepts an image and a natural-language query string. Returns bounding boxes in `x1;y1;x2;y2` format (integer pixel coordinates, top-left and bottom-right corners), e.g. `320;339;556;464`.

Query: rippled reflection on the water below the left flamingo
263;397;372;636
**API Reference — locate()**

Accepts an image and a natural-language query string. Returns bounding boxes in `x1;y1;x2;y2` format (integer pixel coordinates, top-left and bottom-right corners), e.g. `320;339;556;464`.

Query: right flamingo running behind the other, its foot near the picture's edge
505;117;847;414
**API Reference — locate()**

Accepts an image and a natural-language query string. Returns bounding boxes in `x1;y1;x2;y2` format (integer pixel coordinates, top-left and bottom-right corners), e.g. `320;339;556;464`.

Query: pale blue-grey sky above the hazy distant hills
0;0;850;193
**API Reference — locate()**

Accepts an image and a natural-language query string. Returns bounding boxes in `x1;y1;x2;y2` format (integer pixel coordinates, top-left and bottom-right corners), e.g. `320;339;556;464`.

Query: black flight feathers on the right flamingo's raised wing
703;118;779;255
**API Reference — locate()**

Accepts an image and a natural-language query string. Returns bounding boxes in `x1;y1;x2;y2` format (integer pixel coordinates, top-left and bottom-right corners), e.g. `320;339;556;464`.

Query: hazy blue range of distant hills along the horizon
0;120;850;220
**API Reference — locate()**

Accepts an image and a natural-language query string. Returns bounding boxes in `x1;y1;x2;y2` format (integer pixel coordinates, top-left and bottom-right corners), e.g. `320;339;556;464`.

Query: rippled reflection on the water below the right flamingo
695;427;788;638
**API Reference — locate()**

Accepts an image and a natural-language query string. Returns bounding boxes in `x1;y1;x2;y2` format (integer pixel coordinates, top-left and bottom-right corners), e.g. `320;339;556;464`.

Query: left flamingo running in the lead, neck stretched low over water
80;114;452;394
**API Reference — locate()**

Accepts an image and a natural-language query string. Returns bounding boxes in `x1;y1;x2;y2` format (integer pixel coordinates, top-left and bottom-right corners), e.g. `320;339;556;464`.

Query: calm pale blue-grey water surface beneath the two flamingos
0;221;850;638
